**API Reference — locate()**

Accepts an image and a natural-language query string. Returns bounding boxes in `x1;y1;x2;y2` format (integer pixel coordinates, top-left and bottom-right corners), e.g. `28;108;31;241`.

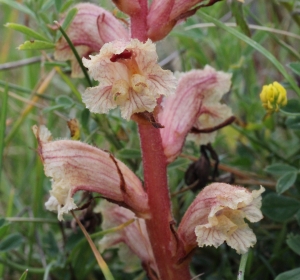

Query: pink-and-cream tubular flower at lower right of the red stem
178;183;265;254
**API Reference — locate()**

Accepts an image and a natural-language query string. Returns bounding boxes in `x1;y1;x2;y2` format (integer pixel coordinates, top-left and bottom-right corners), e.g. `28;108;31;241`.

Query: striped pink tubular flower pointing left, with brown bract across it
33;126;149;220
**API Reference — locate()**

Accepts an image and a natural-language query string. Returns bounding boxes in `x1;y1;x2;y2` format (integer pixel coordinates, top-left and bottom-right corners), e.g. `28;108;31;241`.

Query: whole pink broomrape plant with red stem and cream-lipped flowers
33;0;264;280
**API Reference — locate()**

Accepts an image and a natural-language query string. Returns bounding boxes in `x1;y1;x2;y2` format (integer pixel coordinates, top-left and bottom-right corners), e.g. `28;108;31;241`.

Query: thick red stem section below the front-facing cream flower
139;123;191;280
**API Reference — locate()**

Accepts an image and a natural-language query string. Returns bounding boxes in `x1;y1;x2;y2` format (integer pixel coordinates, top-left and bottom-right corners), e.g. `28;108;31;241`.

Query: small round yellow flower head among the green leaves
260;82;287;113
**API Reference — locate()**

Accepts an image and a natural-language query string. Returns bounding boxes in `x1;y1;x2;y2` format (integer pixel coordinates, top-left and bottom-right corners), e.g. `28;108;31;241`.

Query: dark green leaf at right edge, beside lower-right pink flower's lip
262;193;300;222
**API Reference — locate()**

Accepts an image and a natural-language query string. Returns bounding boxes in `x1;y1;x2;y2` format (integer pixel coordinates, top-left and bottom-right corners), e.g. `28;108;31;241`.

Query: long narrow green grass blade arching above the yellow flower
197;11;300;96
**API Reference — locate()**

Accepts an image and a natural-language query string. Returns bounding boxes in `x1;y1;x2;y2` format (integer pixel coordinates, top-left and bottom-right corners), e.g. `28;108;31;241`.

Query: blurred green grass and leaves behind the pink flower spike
0;0;300;280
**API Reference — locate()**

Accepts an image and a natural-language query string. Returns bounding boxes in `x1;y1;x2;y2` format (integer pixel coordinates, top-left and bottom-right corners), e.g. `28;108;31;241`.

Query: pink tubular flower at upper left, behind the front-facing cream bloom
54;3;130;77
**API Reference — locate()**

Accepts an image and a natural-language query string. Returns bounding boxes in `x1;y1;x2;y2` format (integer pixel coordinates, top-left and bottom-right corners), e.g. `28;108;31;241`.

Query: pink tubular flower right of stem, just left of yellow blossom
158;66;232;162
